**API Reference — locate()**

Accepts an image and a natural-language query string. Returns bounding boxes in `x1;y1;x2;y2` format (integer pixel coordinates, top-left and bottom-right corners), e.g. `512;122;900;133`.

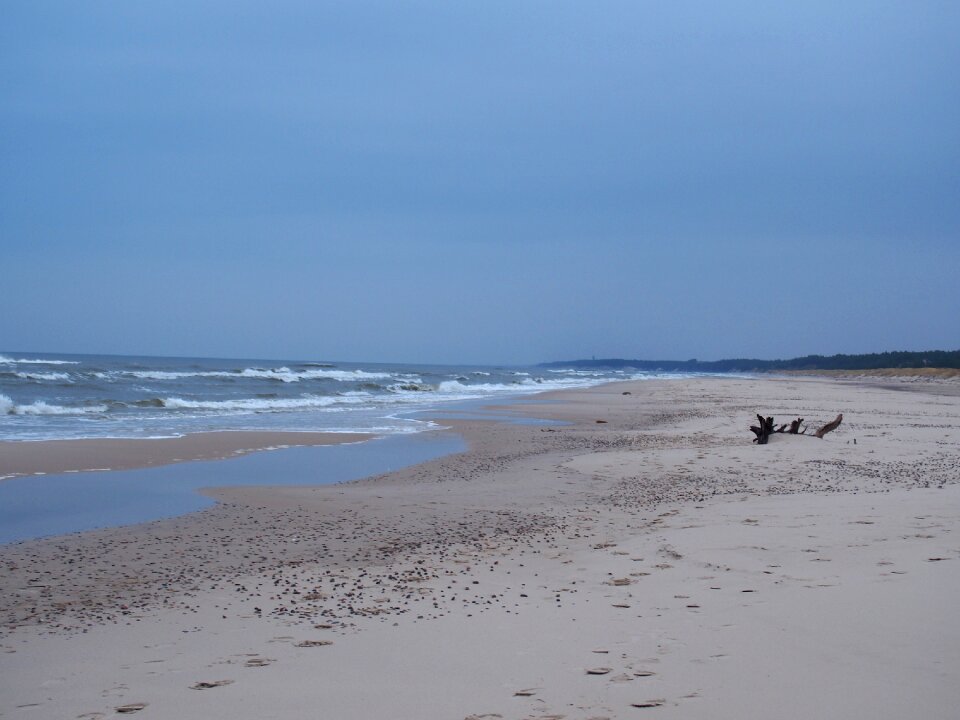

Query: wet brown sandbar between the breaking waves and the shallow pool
0;430;377;482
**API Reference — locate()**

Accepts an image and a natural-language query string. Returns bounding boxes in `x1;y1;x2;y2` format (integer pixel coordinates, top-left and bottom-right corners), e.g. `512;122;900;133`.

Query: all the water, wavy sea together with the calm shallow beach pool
0;352;688;543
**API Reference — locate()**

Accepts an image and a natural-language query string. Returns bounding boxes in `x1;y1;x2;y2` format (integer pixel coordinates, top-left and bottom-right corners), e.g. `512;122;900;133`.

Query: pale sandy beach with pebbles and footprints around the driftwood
0;377;960;720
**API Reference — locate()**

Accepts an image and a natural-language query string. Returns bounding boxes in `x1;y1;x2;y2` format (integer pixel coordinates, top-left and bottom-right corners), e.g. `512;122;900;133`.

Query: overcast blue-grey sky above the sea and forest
0;0;960;364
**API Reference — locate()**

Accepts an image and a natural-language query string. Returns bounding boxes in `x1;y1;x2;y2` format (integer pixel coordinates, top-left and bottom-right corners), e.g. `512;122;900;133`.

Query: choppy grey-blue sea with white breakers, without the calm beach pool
0;352;680;440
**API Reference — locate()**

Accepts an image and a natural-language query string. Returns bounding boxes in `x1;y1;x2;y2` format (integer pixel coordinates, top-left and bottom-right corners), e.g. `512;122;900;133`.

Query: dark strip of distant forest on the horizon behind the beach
540;350;960;372
